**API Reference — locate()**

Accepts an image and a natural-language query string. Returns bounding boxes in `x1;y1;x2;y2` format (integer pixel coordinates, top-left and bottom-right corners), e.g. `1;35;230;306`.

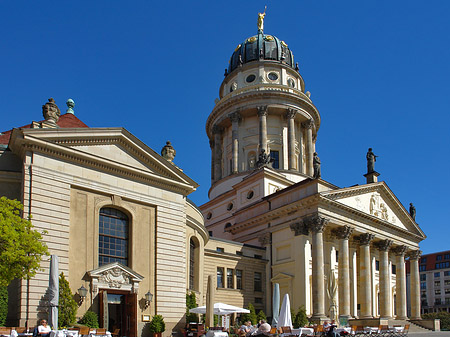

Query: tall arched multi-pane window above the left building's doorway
98;207;128;266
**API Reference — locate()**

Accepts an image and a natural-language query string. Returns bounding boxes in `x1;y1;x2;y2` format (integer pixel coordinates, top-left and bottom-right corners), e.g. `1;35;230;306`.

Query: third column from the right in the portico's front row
377;240;392;319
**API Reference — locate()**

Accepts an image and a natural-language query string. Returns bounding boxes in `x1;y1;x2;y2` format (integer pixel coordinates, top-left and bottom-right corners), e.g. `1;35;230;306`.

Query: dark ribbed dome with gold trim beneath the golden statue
227;30;294;74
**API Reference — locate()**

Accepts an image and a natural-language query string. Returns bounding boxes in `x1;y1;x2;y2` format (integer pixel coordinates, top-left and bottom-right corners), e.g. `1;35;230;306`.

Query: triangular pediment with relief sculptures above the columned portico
322;182;425;238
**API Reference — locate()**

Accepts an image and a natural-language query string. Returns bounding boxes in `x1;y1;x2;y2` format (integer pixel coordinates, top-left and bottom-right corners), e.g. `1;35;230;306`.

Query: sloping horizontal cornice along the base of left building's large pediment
11;131;195;195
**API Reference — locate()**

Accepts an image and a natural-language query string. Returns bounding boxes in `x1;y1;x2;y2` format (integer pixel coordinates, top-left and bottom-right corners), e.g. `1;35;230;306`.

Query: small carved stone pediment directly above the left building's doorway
88;262;144;293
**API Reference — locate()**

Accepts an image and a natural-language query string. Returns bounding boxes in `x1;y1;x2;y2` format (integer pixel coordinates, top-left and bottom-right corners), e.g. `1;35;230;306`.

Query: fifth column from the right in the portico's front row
336;226;353;318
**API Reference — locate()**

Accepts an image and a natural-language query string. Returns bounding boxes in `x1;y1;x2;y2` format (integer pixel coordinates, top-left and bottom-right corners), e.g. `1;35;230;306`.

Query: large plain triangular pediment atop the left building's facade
10;128;198;194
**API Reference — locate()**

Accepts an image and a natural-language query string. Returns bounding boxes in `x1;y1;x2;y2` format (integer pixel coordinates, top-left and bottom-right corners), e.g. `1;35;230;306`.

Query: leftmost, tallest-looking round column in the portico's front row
308;215;328;319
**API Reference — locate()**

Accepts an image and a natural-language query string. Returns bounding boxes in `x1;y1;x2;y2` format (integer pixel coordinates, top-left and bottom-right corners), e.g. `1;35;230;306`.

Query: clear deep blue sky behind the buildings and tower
0;0;450;253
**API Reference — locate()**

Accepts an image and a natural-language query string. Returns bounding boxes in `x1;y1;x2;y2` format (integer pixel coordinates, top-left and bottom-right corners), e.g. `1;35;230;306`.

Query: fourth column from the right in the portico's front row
359;233;374;319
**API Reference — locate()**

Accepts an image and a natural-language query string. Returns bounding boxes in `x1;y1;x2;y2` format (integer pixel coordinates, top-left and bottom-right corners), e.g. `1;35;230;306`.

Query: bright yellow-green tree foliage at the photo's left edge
0;197;48;286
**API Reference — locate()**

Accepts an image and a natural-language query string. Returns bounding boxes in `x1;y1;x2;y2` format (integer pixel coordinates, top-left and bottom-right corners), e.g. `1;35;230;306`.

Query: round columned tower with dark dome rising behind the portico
206;17;320;199
